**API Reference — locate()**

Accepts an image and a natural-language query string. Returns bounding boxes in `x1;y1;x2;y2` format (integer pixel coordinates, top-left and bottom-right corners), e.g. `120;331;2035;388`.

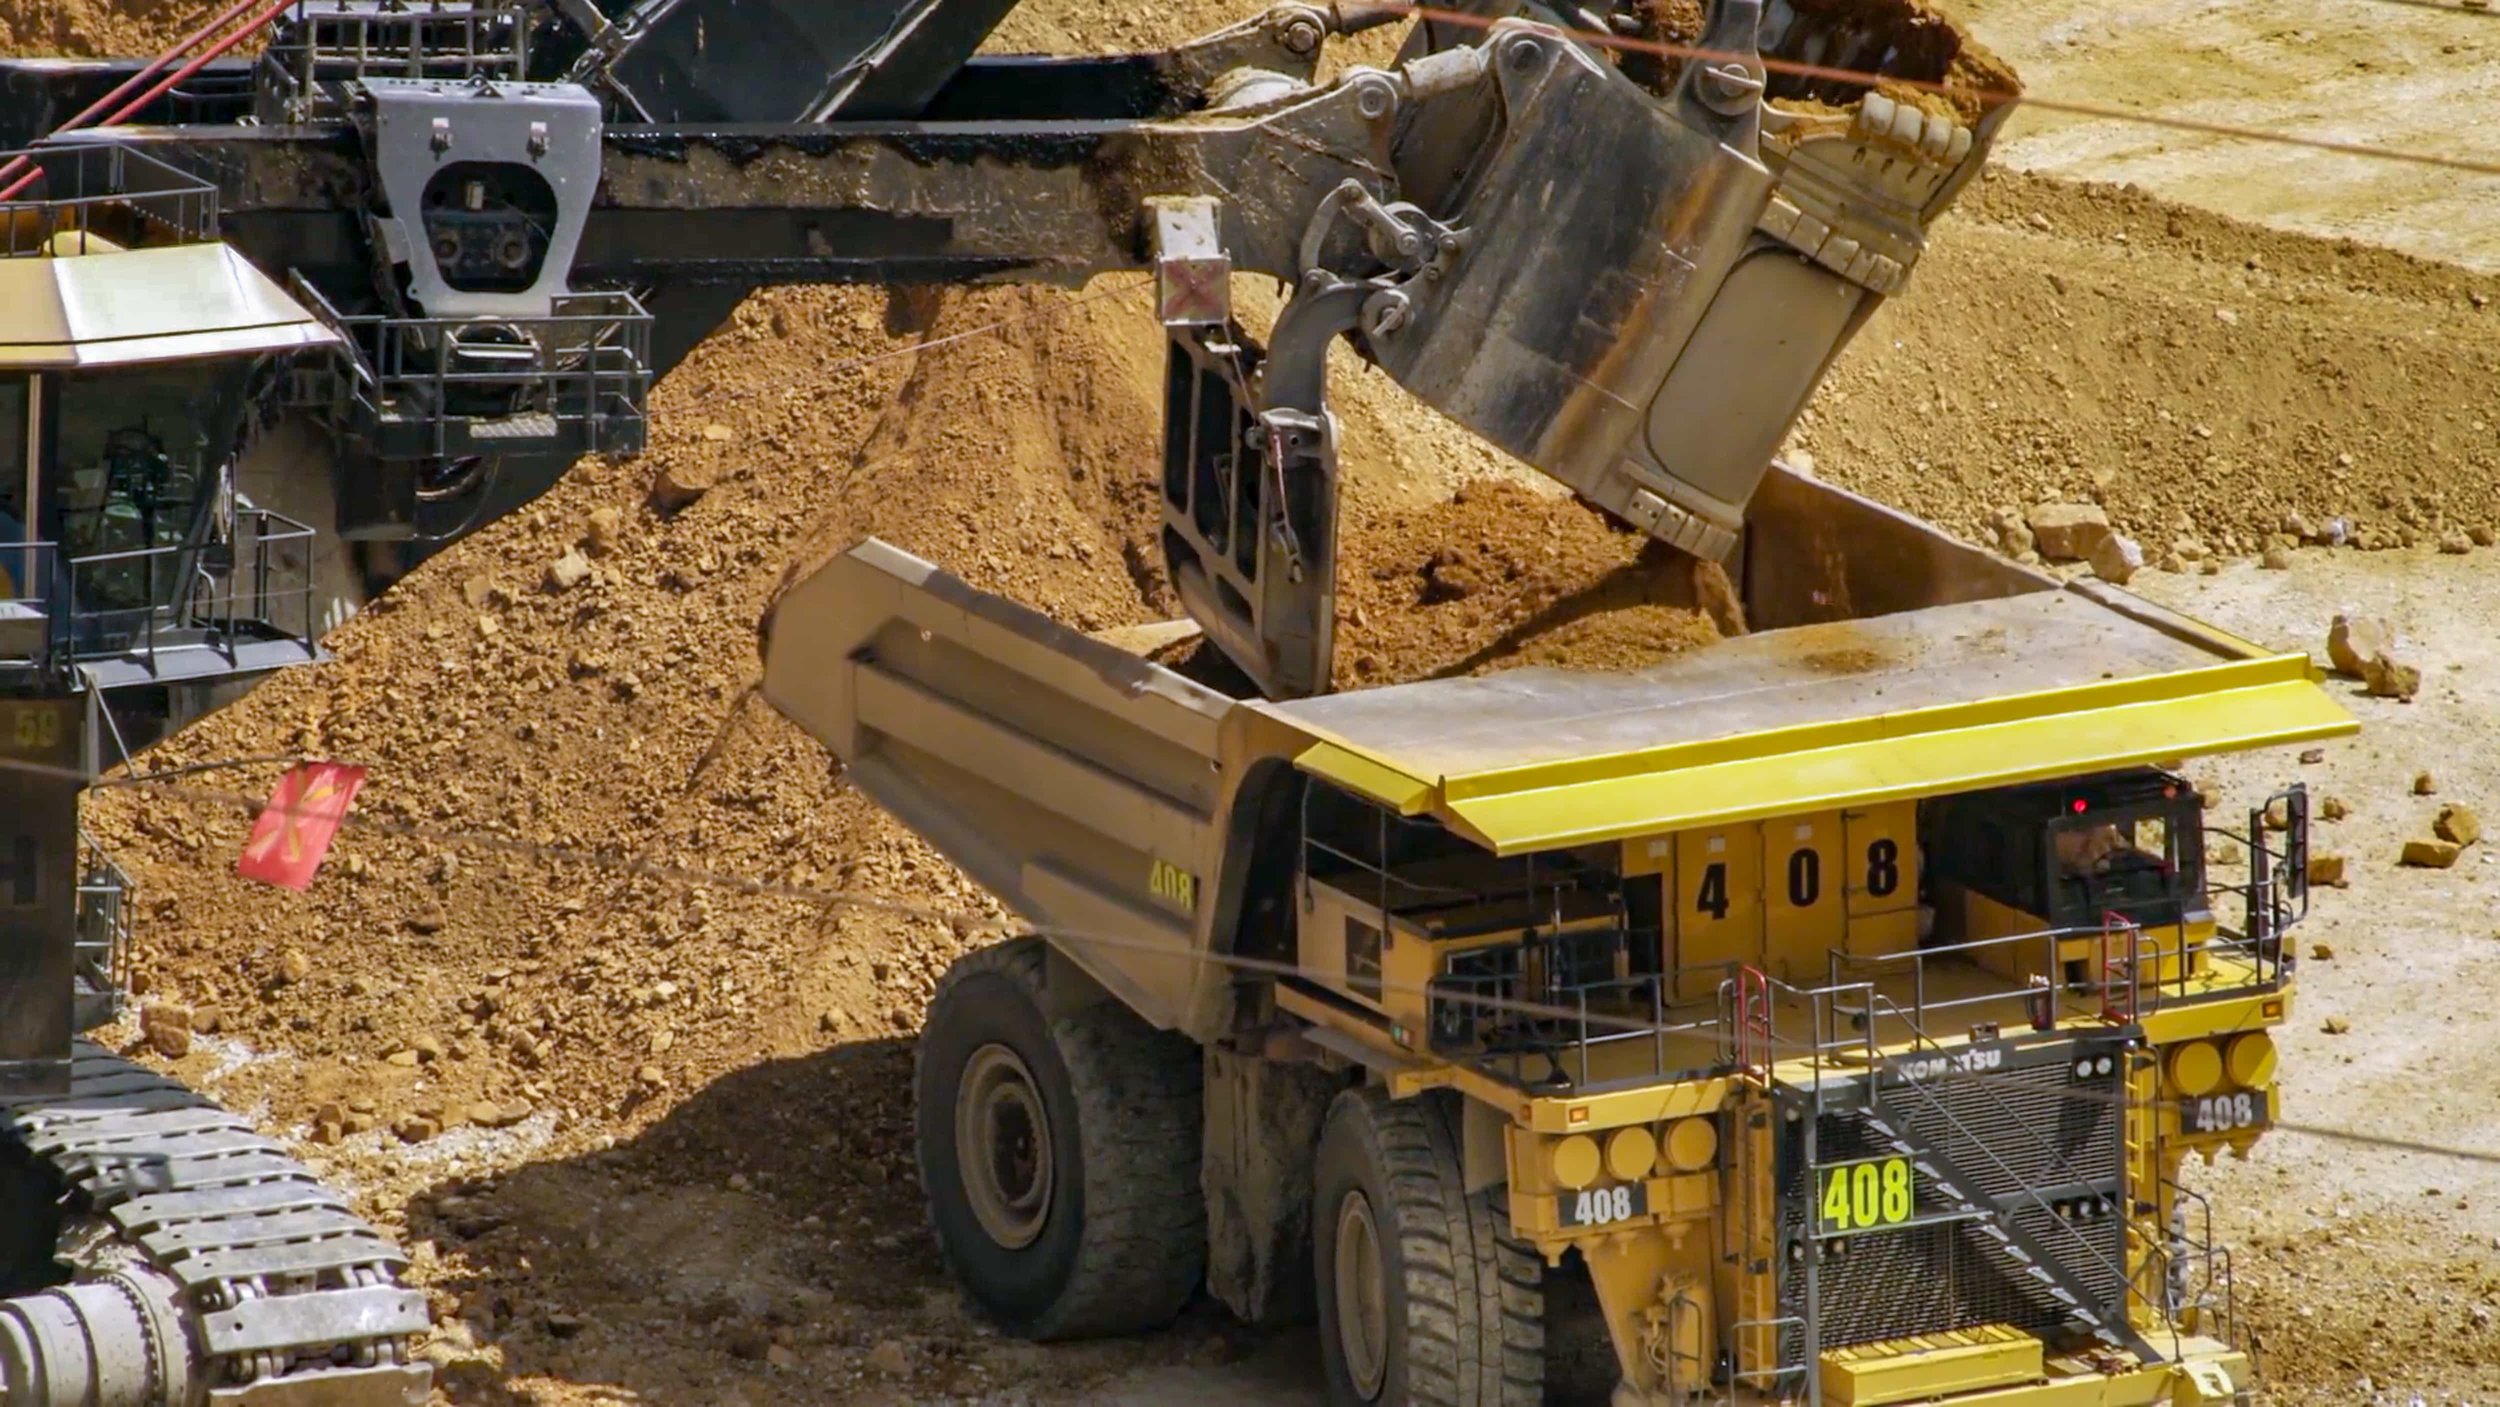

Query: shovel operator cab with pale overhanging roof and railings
0;145;335;747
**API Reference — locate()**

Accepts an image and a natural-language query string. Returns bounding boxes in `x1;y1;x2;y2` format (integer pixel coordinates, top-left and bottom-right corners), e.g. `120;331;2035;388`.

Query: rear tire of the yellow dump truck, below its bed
913;937;1208;1340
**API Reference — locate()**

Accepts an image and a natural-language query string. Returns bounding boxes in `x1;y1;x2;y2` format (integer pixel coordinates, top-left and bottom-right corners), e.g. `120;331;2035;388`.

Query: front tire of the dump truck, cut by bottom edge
1310;1085;1545;1407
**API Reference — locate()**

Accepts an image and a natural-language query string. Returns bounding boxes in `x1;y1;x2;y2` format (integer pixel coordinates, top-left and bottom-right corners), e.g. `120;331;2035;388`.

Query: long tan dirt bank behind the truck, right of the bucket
1798;172;2500;560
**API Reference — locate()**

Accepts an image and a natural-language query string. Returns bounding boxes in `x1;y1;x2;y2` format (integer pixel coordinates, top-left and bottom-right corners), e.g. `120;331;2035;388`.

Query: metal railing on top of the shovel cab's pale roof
0;142;218;257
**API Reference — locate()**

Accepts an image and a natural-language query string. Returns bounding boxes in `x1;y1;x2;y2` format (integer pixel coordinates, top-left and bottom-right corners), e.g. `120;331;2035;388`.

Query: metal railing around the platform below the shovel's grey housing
288;272;650;460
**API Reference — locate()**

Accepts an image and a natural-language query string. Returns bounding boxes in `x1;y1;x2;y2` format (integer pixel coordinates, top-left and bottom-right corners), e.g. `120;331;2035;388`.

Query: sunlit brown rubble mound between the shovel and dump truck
90;292;1168;1122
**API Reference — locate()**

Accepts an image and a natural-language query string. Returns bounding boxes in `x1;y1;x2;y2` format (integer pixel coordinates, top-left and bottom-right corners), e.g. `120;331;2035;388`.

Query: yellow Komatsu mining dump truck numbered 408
763;470;2355;1407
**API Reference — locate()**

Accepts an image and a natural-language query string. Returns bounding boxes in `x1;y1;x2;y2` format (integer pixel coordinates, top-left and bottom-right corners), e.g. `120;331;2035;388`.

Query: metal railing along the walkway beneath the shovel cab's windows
0;507;318;675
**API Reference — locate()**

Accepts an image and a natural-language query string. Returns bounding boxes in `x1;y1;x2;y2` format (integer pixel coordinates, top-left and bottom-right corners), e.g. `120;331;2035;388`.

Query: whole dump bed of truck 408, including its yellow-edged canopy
765;470;2353;1037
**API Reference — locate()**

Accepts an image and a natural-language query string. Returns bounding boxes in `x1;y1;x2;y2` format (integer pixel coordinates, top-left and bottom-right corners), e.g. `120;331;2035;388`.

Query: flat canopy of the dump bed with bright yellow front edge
1253;590;2343;855
